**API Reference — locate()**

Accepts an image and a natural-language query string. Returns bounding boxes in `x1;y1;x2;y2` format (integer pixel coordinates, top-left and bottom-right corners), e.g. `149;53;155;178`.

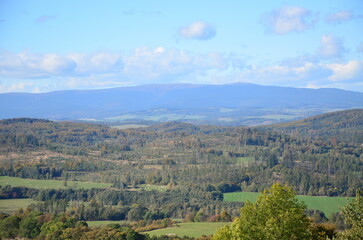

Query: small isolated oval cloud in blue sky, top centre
178;22;217;40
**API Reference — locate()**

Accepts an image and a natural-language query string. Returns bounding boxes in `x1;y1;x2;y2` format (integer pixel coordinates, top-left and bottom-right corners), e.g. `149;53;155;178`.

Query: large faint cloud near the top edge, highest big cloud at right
261;6;315;35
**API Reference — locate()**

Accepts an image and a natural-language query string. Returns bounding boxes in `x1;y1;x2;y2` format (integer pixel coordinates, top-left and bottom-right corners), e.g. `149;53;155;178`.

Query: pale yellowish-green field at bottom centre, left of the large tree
146;222;230;237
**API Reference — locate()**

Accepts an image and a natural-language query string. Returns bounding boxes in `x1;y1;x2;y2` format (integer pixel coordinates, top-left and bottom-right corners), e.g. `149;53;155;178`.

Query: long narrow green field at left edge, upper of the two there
0;176;111;189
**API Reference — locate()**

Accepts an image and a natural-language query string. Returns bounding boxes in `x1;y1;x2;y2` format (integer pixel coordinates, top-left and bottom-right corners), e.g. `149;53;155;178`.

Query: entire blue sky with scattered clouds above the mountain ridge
0;0;363;93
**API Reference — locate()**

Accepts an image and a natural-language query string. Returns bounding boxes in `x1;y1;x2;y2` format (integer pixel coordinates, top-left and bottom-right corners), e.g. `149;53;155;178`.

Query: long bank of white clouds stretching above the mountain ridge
0;46;363;92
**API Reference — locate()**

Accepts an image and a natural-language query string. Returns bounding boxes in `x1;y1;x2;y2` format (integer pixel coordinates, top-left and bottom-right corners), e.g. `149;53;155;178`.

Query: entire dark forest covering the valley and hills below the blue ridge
0;110;363;239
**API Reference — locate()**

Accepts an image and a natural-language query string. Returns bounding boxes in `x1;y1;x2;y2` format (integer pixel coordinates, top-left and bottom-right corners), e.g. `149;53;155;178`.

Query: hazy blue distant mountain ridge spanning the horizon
0;83;363;124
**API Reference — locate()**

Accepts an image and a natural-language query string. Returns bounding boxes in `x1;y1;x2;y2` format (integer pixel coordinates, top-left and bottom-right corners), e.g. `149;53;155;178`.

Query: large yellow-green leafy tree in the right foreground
213;183;311;240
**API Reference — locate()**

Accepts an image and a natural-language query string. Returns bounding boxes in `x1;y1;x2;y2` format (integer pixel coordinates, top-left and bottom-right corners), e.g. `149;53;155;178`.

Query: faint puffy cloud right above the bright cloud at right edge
317;34;347;58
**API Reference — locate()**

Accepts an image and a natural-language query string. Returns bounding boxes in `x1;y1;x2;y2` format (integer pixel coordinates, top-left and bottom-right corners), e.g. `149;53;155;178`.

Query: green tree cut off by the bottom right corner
341;191;363;240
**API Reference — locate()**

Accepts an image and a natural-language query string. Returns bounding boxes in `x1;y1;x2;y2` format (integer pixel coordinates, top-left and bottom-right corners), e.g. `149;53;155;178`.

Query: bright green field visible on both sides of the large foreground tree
224;192;348;217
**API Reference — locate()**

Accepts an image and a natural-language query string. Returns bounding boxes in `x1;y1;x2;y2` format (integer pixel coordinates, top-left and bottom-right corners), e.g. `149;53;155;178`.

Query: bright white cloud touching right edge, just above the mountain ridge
326;60;363;82
